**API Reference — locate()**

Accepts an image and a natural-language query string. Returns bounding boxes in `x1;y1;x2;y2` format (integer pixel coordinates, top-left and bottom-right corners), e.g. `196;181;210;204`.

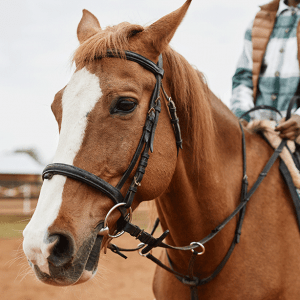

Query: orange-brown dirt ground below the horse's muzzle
0;235;161;300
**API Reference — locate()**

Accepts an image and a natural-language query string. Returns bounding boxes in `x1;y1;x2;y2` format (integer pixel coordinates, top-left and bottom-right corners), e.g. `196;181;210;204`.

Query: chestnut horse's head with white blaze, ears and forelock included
23;0;191;285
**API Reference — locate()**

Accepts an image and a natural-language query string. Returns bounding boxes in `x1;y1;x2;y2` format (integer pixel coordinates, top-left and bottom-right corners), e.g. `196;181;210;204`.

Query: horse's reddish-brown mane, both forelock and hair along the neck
73;22;215;170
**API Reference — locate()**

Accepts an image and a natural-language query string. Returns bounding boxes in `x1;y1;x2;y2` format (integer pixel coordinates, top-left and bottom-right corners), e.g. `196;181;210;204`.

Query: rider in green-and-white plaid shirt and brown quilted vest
230;0;300;140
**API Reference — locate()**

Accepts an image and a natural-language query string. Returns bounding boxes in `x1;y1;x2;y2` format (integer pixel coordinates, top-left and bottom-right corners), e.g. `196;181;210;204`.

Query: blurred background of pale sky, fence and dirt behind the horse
0;0;267;300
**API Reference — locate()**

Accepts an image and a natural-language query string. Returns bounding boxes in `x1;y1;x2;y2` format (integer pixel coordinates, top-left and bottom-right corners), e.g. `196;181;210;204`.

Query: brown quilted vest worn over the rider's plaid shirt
252;0;300;103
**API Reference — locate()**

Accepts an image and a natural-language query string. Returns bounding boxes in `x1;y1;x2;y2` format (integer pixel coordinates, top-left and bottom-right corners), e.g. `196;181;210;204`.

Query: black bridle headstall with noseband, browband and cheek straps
42;50;182;220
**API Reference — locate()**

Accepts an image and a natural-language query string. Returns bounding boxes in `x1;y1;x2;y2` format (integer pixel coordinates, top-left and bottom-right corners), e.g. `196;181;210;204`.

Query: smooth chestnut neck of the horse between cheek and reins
157;88;243;273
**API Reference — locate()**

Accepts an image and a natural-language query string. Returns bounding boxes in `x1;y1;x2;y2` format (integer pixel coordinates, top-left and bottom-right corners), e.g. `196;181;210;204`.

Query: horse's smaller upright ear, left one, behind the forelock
77;9;101;44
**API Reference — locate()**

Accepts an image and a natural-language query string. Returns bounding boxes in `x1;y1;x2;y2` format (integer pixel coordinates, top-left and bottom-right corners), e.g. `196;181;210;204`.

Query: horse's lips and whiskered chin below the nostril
32;235;103;286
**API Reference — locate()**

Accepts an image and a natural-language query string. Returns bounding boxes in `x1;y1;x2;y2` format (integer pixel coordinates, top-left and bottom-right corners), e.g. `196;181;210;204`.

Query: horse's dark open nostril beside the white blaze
48;234;74;267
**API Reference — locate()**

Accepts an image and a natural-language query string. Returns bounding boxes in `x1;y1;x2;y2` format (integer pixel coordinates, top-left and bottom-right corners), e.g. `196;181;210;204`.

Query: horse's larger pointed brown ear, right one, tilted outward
144;0;192;55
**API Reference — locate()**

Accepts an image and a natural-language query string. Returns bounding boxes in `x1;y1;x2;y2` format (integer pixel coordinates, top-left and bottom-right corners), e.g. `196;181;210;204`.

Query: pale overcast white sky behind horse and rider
0;0;268;164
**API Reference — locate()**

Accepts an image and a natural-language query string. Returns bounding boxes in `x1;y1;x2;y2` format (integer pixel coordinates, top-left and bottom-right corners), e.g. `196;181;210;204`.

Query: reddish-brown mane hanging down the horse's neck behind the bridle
163;47;215;171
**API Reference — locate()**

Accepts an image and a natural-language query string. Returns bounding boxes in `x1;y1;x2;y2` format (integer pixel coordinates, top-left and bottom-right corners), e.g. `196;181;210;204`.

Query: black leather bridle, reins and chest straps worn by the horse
42;51;297;299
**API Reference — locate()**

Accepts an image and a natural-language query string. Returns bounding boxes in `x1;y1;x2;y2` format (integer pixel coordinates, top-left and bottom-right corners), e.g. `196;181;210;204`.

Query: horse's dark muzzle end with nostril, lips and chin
24;232;103;286
